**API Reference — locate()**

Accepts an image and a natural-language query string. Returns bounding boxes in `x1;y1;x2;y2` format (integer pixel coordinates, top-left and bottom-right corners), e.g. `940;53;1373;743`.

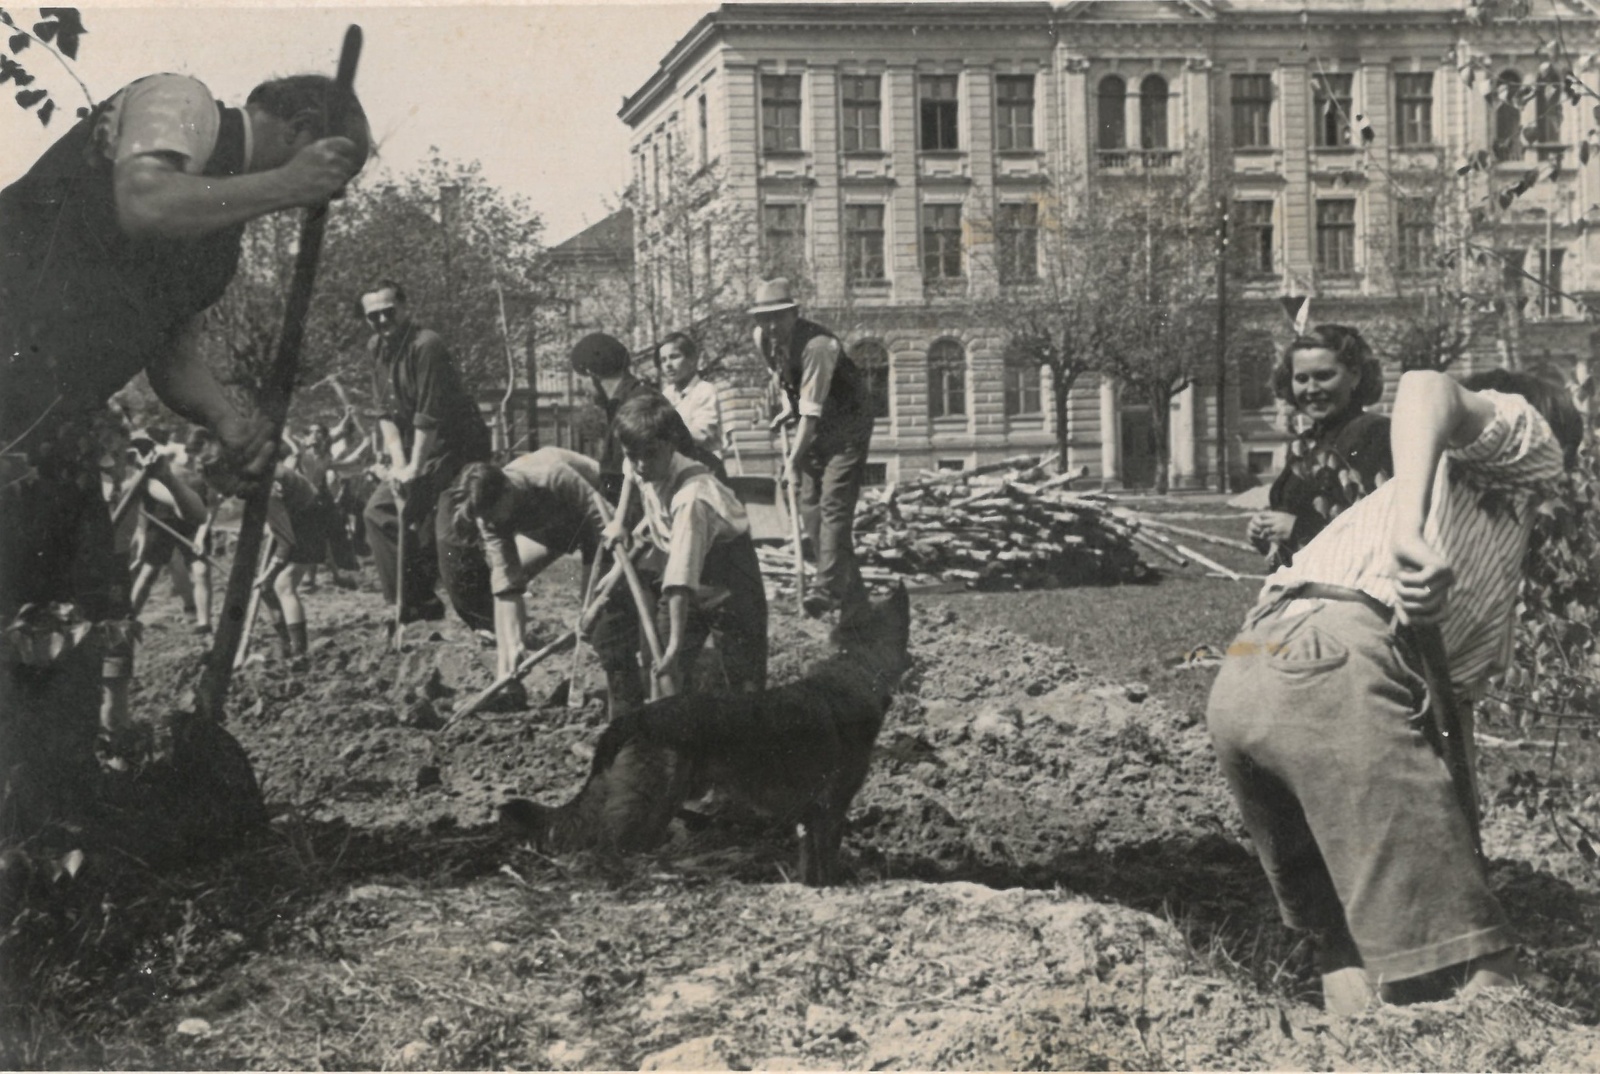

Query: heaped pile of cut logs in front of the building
856;456;1150;589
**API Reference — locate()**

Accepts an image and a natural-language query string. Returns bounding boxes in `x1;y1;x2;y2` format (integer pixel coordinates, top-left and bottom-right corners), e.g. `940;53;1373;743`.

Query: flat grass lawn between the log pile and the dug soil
917;499;1264;717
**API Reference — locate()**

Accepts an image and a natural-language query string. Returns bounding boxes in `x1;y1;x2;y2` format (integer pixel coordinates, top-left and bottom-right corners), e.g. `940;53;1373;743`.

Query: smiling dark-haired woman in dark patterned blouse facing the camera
1250;325;1394;568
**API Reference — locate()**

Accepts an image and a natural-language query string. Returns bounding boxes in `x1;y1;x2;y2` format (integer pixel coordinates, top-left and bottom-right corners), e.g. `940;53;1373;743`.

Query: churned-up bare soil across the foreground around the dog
0;550;1600;1069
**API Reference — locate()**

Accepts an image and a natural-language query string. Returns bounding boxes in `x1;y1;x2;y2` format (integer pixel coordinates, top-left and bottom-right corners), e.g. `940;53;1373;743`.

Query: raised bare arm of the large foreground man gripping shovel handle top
112;140;357;238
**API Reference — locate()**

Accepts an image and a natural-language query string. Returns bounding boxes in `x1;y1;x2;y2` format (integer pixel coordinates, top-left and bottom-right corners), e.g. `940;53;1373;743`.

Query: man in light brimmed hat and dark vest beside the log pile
749;279;872;616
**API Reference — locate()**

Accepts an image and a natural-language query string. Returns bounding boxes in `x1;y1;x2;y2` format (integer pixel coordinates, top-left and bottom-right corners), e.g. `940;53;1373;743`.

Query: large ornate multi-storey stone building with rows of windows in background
621;0;1600;487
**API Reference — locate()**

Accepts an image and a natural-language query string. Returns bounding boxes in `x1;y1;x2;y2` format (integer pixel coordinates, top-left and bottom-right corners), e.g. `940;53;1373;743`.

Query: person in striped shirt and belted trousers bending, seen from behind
1206;370;1582;1013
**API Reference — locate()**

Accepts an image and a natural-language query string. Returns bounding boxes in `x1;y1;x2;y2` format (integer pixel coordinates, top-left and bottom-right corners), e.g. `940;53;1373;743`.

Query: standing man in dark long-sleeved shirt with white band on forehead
362;280;490;621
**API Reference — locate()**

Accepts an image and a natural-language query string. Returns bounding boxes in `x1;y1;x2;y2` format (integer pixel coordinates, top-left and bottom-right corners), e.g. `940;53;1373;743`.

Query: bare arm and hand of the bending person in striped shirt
1389;370;1494;623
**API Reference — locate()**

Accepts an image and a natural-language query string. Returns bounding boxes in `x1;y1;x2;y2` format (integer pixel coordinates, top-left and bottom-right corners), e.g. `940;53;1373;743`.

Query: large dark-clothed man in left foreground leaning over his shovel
0;75;370;831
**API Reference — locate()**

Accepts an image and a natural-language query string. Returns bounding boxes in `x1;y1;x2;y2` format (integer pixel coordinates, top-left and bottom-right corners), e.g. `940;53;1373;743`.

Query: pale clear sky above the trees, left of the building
0;0;714;245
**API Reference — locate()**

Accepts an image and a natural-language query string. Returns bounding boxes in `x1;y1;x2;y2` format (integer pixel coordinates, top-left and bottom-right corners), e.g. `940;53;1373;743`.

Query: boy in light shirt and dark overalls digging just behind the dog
611;394;766;690
